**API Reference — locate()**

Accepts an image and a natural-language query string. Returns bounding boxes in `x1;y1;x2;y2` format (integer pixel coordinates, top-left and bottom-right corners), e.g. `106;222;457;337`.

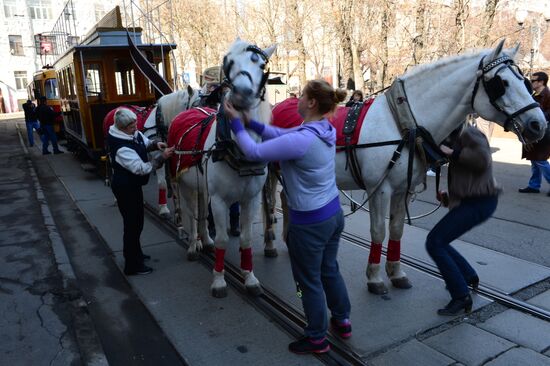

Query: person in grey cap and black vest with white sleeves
107;108;174;276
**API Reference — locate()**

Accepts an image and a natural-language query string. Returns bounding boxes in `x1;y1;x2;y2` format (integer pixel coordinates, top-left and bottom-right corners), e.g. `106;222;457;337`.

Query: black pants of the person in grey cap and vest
112;186;143;271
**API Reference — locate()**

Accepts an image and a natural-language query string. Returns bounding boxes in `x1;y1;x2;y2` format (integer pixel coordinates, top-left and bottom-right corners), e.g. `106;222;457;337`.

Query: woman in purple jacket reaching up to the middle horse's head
224;80;351;354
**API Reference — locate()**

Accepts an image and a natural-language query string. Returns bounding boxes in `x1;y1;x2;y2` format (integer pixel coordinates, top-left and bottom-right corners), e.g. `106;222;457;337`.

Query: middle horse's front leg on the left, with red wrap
210;195;229;298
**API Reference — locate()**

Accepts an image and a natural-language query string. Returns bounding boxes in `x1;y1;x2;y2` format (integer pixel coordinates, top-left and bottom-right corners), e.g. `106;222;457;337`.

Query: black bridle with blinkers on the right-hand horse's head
470;55;539;138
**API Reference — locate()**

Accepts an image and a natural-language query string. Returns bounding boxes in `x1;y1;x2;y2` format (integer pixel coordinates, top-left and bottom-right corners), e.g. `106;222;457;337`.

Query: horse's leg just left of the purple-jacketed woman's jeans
262;169;278;258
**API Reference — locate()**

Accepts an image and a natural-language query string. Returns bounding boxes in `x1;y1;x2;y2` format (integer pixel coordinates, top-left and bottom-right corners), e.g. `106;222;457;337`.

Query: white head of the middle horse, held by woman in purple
223;39;277;109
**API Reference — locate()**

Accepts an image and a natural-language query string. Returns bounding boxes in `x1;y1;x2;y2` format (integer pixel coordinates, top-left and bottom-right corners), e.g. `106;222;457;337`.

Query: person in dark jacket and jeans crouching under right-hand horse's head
426;127;501;315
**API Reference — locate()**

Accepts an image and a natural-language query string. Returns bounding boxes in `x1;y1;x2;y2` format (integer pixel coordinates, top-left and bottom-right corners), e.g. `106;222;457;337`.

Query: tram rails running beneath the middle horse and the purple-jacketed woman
145;203;366;365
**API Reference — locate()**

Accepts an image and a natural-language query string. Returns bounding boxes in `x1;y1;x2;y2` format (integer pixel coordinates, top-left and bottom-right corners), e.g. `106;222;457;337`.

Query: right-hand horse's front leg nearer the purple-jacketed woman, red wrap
367;186;390;295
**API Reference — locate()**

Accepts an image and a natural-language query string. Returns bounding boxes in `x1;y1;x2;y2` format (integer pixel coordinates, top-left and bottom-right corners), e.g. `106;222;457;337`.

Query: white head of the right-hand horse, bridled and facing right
471;40;546;143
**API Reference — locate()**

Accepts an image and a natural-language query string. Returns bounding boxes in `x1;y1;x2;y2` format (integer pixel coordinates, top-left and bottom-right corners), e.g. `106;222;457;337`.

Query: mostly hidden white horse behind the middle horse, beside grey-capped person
142;87;200;218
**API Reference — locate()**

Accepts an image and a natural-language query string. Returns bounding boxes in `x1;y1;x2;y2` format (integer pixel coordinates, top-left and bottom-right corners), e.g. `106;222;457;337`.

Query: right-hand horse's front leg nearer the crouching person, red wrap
386;194;412;289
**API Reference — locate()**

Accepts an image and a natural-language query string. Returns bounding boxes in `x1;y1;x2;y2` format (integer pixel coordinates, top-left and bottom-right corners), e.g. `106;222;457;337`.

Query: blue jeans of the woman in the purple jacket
287;211;351;339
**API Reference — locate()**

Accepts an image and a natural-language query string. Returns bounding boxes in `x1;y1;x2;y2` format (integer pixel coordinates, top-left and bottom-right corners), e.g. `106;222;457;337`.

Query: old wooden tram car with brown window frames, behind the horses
54;7;176;160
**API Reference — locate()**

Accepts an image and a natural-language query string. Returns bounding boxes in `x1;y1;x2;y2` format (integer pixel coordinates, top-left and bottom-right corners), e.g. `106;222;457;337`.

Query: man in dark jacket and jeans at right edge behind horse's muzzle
519;72;550;197
